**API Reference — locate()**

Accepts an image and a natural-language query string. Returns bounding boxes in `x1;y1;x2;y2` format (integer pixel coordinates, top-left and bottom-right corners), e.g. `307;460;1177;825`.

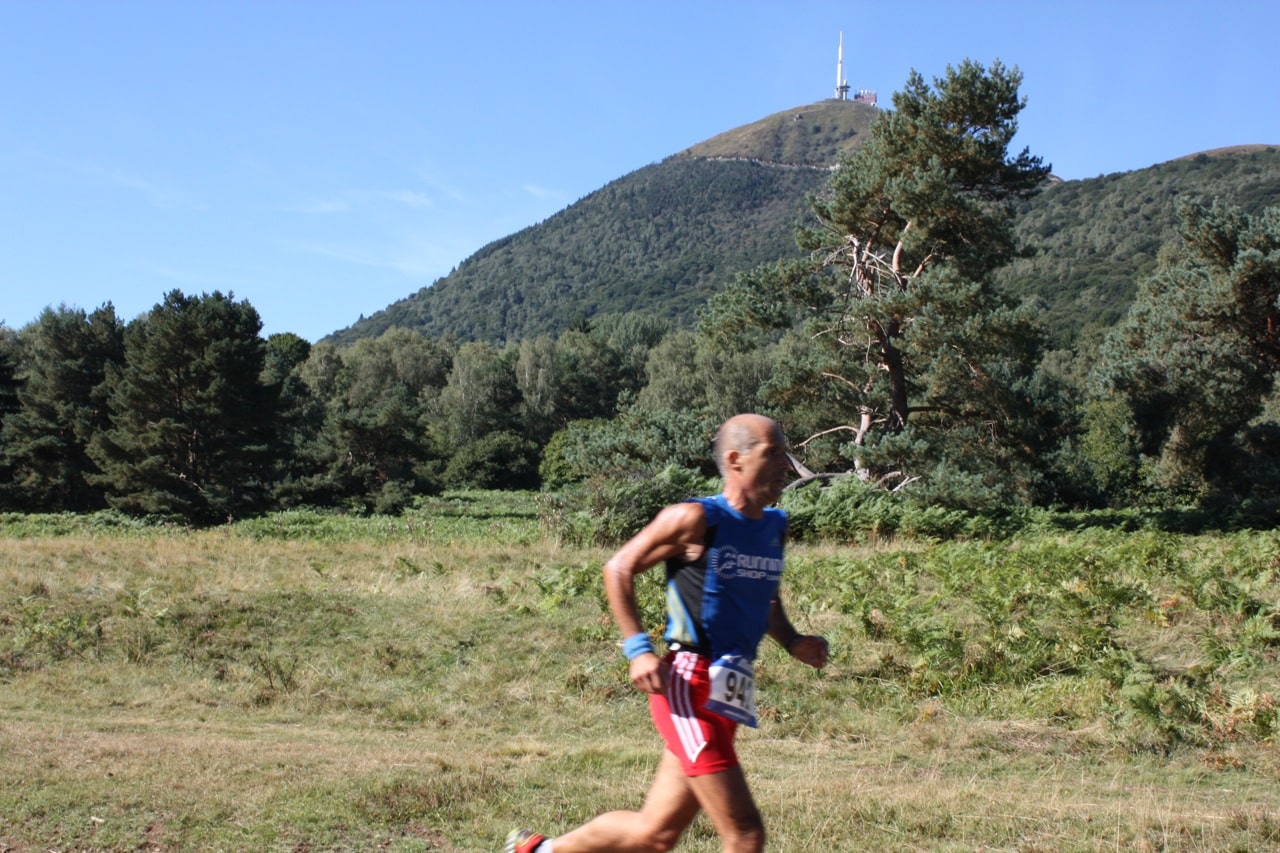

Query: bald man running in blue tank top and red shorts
506;415;827;853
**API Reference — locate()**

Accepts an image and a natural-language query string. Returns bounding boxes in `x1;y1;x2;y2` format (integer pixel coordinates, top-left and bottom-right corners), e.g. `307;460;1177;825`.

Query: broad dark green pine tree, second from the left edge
90;291;278;523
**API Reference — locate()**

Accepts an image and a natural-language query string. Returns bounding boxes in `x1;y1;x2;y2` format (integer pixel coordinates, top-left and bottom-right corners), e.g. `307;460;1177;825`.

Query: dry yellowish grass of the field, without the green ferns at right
0;502;1280;852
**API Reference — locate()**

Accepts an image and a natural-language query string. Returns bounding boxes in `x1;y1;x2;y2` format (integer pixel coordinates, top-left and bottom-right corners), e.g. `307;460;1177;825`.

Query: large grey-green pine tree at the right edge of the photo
1091;202;1280;497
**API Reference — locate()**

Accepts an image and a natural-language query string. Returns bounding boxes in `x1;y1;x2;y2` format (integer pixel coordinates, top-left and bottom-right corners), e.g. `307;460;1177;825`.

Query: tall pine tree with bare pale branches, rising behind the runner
704;60;1048;499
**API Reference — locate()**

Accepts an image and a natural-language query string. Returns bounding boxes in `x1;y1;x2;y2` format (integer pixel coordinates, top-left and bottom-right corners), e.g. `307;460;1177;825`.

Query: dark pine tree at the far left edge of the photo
3;302;124;512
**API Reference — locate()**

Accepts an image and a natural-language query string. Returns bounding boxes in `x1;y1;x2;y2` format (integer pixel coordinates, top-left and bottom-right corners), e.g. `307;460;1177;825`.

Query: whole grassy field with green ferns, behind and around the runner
0;494;1280;852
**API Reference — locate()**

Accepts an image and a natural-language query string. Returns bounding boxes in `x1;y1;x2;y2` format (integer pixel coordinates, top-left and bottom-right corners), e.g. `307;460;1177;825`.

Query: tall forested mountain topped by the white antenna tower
329;100;877;345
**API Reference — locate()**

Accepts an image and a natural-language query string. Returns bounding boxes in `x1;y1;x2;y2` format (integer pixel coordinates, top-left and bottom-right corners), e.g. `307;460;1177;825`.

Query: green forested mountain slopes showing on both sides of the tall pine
328;100;1280;347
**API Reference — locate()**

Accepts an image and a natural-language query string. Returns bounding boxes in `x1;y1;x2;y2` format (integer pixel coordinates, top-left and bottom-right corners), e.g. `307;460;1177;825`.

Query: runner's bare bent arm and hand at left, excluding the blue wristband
604;503;707;693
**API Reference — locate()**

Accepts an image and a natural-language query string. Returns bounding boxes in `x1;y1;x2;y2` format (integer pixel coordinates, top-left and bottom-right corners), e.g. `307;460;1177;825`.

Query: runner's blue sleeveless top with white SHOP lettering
664;494;787;660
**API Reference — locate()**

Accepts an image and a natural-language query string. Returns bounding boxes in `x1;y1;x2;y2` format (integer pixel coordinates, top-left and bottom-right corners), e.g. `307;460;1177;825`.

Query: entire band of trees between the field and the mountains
0;60;1280;524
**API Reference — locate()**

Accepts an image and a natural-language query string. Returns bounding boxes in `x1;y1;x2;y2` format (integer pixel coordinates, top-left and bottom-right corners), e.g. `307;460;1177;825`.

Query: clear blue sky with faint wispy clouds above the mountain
0;0;1280;341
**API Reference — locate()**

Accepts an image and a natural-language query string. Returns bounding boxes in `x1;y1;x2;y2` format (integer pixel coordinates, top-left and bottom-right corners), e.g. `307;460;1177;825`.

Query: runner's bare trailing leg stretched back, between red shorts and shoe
553;749;701;853
